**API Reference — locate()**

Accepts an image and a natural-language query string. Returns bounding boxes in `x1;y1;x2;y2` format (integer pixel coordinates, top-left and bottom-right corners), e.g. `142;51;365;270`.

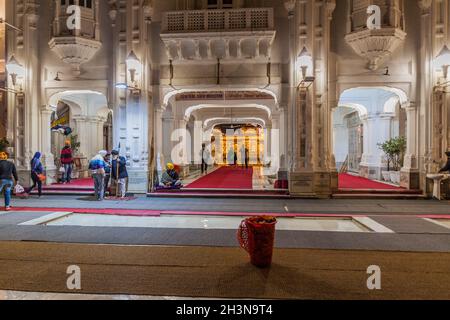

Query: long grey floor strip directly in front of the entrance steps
6;196;450;215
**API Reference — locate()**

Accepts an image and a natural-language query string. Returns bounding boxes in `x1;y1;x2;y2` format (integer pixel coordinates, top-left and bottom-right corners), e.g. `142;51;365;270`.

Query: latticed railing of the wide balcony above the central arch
162;8;274;33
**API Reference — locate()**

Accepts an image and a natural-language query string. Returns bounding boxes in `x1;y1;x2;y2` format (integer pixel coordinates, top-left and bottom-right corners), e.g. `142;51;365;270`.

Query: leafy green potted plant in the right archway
378;137;406;184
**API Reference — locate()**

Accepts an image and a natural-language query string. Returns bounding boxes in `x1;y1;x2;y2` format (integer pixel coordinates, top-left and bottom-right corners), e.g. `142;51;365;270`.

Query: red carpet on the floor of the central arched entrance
186;167;253;189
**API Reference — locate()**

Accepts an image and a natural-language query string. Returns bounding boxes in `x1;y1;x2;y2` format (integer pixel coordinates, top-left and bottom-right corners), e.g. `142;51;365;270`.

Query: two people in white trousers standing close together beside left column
89;150;128;201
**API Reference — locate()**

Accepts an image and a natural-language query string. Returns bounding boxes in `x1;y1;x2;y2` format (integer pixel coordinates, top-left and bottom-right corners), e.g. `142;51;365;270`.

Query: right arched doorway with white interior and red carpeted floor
333;87;415;190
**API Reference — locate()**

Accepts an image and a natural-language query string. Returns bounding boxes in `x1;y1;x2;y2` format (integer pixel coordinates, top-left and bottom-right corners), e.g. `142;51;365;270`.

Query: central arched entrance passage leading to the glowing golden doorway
155;88;284;189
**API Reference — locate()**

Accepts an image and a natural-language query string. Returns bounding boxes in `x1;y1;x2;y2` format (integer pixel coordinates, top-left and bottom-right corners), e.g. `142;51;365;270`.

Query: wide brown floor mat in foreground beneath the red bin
0;242;450;300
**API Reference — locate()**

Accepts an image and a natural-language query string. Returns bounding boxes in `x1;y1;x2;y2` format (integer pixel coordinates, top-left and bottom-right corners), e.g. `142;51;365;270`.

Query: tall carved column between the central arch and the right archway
290;0;336;197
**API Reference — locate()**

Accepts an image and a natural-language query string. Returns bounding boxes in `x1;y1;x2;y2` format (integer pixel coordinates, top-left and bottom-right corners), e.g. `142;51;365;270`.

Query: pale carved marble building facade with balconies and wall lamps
2;0;450;197
